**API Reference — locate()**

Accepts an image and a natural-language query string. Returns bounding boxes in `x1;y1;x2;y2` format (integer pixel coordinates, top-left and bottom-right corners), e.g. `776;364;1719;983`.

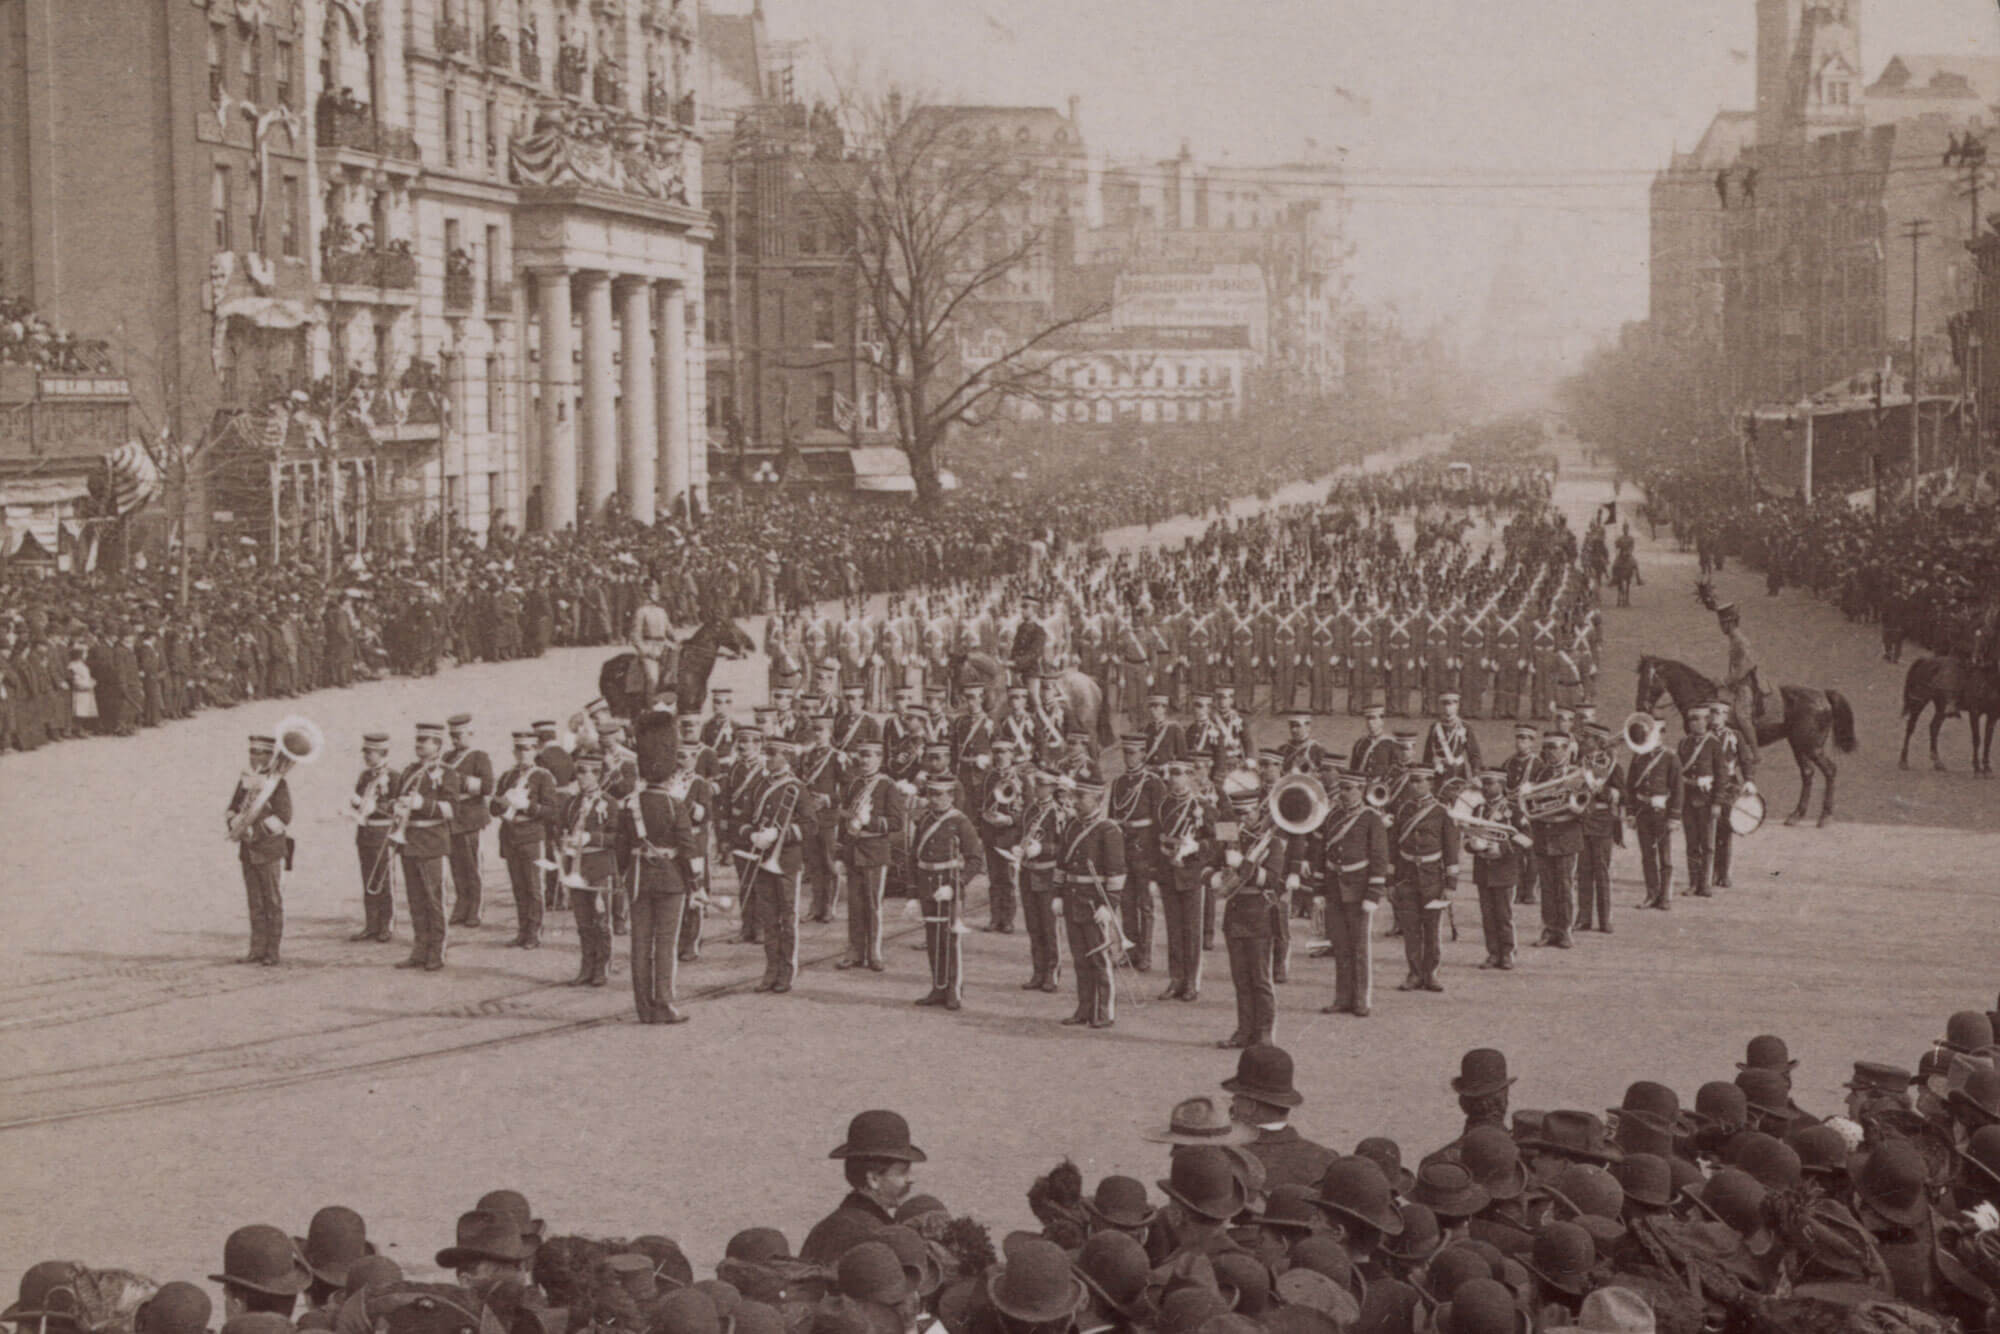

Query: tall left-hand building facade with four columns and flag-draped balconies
0;0;708;550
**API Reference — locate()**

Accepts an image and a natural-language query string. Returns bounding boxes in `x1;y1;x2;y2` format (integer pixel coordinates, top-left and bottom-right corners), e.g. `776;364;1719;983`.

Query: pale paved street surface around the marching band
0;438;2000;1286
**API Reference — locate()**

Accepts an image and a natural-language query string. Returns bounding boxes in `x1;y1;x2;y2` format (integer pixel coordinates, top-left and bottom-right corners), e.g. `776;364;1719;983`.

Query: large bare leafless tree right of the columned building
808;92;1108;508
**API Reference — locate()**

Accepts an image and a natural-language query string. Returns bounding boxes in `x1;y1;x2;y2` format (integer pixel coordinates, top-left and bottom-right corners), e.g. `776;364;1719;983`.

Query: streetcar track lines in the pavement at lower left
0;900;978;1132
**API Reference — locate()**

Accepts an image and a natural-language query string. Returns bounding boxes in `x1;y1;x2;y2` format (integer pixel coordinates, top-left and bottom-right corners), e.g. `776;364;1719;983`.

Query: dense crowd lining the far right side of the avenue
1644;468;2000;658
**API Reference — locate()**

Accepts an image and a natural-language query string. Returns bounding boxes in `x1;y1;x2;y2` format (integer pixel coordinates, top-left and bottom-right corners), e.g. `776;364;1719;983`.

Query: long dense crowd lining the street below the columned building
0;422;1376;752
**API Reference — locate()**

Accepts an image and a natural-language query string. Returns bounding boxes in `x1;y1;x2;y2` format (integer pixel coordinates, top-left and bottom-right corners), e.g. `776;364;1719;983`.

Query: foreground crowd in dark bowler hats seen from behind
23;1010;2000;1334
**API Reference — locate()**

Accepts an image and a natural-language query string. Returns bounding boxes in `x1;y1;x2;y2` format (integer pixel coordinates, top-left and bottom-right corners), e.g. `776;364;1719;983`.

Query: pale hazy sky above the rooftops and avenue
752;0;2000;350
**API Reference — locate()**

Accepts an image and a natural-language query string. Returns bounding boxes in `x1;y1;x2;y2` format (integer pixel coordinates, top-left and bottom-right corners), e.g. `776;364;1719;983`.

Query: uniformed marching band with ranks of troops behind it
230;470;1752;1046
